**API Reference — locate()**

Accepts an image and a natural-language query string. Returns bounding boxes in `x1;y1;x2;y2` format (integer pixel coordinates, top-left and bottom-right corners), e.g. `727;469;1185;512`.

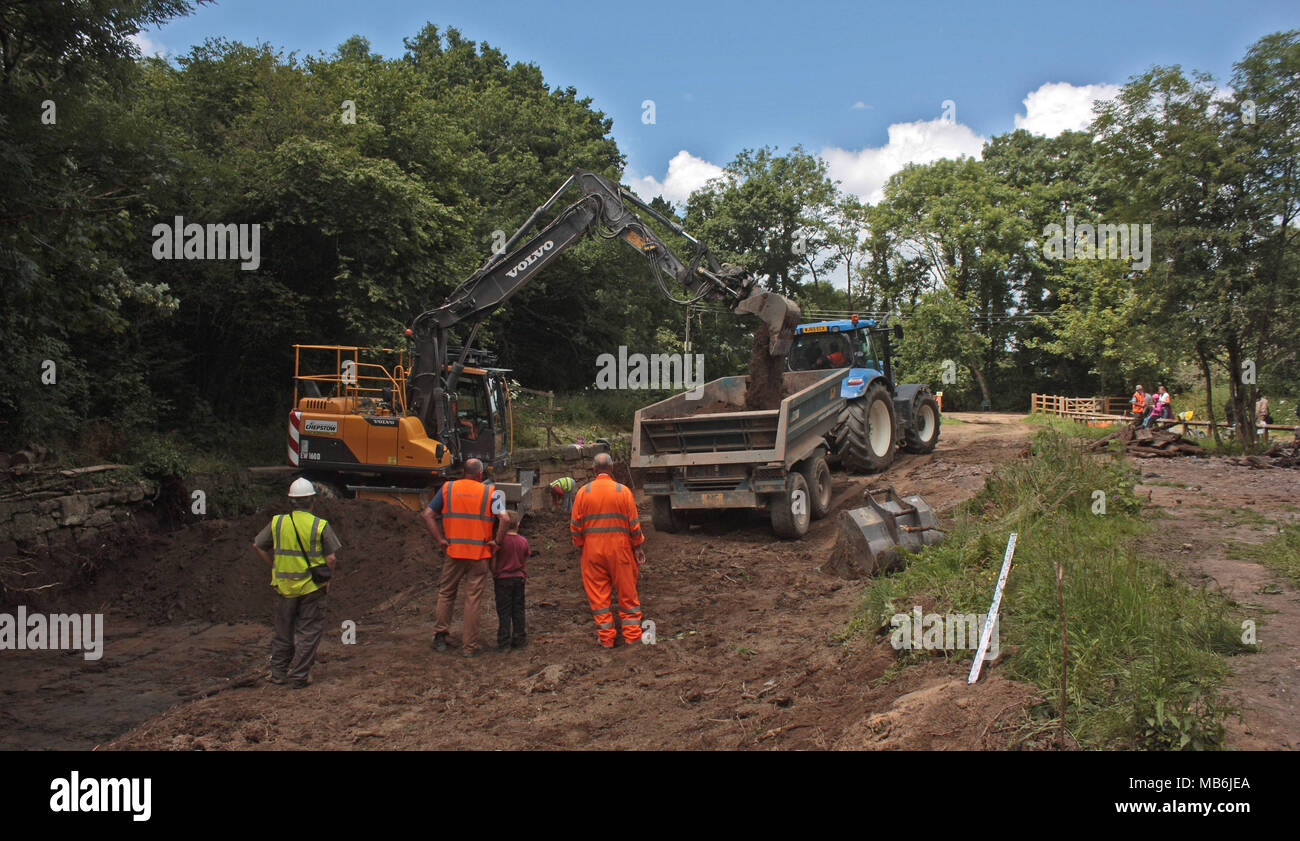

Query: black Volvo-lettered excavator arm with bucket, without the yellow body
407;169;798;462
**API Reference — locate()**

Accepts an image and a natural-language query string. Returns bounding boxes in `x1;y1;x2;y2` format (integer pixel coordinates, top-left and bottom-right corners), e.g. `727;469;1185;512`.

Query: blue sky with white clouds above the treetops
134;0;1300;200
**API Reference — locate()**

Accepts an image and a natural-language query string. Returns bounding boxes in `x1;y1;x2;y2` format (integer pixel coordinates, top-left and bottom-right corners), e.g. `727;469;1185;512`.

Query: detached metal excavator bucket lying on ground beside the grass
822;486;944;578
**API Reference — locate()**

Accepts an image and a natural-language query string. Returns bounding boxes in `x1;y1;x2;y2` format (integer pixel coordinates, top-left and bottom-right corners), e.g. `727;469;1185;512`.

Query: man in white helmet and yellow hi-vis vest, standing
252;478;341;689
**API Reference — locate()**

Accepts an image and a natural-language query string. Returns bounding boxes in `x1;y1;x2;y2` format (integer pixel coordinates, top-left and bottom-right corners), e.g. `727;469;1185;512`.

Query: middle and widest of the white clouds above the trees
822;118;984;204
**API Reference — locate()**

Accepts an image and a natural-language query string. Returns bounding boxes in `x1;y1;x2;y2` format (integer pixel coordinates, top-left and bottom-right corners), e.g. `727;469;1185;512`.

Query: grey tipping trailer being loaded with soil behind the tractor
631;370;844;538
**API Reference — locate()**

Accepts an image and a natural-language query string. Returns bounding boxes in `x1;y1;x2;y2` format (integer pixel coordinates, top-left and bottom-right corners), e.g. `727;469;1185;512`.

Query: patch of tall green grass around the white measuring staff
852;421;1249;749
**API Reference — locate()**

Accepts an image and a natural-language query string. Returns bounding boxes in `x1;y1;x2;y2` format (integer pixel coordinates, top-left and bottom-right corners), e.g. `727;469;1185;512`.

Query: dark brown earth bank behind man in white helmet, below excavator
56;499;438;623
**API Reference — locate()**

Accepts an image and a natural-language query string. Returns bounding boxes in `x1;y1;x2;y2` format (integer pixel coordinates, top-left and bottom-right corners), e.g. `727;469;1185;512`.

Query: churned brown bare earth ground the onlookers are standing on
0;416;1032;749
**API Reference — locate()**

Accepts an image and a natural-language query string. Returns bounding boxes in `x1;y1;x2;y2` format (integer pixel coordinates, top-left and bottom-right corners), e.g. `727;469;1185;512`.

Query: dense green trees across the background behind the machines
0;0;1300;456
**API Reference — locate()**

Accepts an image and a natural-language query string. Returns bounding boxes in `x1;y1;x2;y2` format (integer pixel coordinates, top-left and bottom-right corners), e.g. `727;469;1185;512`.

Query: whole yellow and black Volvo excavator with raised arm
289;169;798;508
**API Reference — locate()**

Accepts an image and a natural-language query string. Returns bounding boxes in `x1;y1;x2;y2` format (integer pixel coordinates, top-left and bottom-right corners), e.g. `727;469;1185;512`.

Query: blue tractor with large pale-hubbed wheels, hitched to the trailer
785;316;939;472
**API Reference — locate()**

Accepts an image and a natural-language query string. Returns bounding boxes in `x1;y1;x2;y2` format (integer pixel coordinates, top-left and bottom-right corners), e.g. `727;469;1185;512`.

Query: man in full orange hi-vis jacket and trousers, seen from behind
569;452;646;649
